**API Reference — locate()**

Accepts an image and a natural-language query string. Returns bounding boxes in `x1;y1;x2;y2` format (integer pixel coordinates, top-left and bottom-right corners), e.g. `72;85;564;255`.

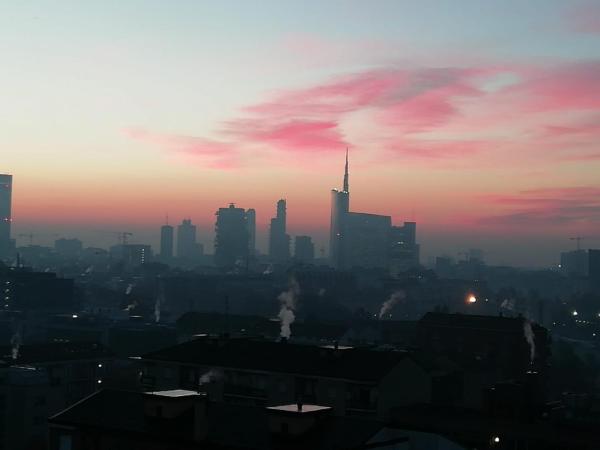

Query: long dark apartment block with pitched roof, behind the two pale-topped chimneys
141;337;433;419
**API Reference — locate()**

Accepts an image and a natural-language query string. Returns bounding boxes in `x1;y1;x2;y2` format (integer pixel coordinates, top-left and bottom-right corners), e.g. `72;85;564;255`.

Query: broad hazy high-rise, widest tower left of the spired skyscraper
215;203;249;268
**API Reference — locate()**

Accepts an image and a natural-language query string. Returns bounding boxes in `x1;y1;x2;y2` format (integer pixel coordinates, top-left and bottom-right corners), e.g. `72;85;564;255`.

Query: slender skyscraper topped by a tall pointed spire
329;148;350;268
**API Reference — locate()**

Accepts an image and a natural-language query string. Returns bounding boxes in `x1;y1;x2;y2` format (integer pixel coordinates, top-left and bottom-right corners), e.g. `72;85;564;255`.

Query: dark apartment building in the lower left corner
0;343;113;450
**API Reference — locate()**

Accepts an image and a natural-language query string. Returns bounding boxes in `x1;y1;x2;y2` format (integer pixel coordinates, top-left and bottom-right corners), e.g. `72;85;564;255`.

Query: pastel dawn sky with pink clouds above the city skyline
0;0;600;266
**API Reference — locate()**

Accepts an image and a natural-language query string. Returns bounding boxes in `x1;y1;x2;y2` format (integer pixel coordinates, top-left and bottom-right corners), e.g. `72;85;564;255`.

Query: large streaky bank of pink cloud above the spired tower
129;61;600;167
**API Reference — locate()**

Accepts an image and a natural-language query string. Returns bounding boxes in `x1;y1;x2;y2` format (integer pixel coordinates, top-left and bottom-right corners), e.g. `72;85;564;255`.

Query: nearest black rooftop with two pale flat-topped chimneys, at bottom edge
49;390;463;450
